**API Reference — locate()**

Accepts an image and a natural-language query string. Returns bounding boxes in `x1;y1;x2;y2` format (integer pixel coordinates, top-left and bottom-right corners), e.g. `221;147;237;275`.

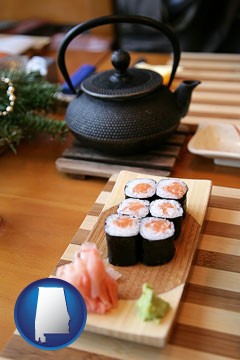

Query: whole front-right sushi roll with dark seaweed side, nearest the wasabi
140;217;175;266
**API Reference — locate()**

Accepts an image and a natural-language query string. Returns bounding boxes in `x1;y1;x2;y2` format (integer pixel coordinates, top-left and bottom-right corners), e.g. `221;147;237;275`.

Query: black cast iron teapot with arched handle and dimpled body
58;15;200;155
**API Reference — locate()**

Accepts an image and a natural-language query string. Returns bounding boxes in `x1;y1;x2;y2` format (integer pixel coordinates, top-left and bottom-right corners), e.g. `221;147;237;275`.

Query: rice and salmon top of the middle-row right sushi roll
150;199;183;219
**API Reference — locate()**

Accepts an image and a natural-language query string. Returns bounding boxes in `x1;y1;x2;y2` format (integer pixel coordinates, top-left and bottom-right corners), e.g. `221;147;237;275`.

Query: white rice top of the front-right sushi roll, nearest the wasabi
140;217;175;241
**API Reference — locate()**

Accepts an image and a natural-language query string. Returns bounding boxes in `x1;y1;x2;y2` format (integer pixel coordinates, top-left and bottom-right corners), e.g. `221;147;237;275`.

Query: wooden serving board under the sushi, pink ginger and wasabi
59;171;211;347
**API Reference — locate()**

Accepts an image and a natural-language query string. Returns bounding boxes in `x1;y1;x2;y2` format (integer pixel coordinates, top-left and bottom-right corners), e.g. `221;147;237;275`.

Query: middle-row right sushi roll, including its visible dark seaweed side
150;199;183;239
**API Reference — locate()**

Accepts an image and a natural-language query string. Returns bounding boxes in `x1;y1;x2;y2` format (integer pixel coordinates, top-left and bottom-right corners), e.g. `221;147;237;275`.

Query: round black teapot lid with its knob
81;49;163;99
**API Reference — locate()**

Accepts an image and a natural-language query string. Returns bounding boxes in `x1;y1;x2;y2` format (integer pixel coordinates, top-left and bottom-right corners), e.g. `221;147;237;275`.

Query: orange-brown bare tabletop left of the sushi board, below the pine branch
0;136;105;348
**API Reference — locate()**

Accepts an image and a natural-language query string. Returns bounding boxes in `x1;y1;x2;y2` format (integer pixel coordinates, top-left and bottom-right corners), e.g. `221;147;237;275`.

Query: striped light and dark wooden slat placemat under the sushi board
1;172;240;360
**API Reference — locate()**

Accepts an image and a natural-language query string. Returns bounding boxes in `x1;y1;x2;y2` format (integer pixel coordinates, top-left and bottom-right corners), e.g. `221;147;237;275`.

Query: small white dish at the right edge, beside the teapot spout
188;123;240;167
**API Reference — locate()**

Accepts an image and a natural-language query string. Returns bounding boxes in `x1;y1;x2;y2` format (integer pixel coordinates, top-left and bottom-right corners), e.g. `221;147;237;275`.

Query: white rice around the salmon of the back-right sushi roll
156;178;188;200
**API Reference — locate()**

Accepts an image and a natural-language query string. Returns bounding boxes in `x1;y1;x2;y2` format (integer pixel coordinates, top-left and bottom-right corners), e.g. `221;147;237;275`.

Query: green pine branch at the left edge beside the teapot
0;71;68;152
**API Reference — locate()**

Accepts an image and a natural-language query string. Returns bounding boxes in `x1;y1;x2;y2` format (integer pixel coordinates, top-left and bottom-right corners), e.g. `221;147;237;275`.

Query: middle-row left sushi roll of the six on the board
117;198;150;218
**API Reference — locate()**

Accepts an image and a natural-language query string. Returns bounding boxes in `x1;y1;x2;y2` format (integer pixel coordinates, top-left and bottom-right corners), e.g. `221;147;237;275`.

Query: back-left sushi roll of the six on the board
124;179;156;201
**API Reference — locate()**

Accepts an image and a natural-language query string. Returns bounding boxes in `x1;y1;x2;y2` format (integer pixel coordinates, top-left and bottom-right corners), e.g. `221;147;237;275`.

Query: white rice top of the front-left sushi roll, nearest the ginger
105;214;139;237
